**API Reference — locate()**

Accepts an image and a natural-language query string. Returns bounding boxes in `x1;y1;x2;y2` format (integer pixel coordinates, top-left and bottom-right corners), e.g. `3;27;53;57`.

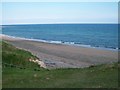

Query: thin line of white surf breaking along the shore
0;34;119;51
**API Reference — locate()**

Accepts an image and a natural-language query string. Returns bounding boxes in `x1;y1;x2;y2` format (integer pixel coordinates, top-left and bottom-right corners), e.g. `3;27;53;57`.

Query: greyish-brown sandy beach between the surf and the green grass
2;35;118;68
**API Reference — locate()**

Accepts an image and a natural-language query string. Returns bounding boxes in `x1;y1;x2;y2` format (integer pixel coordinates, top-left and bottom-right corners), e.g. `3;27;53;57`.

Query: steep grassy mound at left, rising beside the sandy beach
2;42;38;68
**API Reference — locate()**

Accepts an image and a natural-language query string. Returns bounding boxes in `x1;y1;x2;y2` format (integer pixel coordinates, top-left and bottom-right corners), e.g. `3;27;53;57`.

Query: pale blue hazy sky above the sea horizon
0;2;118;24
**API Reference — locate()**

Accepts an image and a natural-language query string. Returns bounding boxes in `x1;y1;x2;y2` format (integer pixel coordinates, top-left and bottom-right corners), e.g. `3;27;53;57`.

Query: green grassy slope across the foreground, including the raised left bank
3;43;119;88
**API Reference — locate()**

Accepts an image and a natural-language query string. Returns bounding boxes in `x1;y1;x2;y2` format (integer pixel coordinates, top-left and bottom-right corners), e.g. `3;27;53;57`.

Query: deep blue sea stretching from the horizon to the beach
2;24;118;49
